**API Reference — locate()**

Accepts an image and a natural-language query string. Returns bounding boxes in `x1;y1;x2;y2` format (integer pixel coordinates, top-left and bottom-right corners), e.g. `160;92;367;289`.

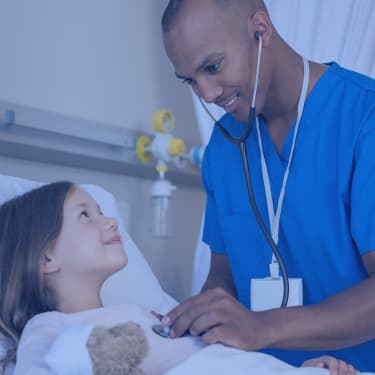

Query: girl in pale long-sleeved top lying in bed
0;182;355;375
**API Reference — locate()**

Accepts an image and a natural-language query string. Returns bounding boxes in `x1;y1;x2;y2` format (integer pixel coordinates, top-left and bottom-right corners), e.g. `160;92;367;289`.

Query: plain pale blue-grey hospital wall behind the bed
0;0;204;300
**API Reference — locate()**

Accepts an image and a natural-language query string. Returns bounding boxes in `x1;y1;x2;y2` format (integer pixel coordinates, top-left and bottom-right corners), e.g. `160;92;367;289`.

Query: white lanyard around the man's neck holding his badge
256;58;310;263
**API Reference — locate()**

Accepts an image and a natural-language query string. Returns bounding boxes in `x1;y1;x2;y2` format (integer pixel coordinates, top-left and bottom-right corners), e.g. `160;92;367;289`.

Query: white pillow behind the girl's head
0;175;176;313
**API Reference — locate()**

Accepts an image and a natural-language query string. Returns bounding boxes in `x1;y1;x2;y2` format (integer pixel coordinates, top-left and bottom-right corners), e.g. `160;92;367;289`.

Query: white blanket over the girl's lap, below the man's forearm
166;345;374;375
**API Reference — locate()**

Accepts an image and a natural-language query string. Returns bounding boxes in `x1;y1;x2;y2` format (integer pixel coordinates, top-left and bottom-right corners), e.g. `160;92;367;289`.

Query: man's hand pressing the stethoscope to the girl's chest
161;288;270;350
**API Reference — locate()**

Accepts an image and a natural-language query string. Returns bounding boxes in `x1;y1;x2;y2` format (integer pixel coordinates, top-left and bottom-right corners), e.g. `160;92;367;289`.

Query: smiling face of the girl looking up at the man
47;187;127;281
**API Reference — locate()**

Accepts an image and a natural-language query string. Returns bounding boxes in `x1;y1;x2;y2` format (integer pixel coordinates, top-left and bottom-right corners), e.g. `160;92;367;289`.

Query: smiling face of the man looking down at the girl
163;0;267;123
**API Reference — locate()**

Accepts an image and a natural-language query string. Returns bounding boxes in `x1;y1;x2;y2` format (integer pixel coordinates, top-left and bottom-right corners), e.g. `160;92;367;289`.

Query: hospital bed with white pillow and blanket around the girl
0;175;374;375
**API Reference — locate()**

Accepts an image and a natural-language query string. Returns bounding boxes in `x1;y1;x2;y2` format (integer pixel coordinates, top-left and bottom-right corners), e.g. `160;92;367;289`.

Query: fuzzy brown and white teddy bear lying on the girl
44;321;148;375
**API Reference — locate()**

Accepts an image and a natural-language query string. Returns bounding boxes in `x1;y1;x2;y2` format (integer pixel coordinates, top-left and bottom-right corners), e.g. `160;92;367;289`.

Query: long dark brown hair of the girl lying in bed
0;181;74;371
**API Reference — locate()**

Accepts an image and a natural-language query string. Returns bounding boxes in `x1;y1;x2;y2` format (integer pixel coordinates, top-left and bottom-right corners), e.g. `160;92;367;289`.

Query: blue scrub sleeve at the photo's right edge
350;106;375;255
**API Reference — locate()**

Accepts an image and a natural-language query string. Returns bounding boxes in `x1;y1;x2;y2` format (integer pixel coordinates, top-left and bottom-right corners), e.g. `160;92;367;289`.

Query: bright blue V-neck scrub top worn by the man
202;63;375;371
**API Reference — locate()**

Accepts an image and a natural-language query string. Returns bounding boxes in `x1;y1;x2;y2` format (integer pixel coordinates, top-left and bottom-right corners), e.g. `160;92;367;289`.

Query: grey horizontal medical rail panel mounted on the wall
0;101;201;187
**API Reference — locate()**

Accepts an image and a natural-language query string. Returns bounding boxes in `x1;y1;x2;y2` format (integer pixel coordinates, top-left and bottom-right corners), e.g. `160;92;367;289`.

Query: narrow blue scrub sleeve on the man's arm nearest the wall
202;146;226;254
